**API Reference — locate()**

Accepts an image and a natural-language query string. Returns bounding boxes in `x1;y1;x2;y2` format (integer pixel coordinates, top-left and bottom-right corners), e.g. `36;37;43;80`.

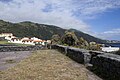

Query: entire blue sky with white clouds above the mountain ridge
0;0;120;40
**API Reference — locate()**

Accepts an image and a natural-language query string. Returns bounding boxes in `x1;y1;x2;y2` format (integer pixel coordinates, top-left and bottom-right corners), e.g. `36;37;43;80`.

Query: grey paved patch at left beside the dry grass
0;51;32;71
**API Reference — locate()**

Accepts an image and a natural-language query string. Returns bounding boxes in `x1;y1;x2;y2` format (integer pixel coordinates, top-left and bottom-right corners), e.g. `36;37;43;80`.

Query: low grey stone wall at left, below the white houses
0;46;43;52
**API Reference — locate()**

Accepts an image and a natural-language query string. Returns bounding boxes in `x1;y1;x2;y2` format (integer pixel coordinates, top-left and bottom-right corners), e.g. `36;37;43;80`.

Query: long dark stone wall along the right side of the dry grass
51;45;120;80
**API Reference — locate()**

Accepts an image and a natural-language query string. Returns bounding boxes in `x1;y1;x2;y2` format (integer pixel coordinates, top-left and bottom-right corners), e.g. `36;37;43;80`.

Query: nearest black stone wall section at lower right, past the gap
91;53;120;80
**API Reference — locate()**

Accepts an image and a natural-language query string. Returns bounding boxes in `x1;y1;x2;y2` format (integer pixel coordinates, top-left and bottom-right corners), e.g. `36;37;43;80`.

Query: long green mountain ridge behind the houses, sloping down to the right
0;20;105;43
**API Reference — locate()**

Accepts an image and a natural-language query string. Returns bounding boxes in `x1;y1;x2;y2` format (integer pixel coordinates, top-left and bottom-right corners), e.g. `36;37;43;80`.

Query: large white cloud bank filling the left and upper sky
0;0;120;36
